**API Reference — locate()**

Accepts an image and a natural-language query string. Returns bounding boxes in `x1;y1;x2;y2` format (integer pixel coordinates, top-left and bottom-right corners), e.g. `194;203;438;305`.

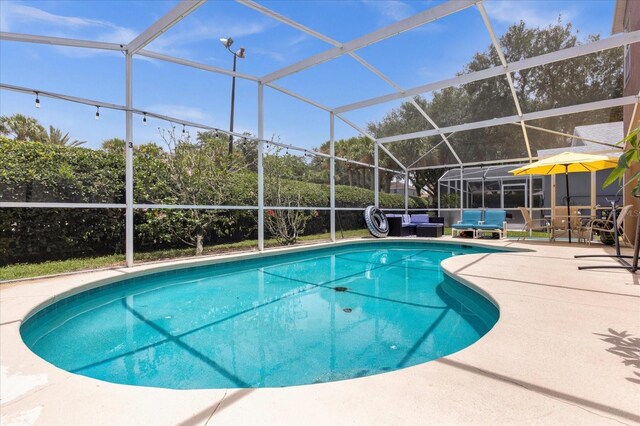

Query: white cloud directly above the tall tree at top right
484;0;574;27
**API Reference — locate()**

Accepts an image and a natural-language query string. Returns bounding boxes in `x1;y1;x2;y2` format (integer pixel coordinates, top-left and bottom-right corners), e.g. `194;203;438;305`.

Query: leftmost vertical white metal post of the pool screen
125;53;133;268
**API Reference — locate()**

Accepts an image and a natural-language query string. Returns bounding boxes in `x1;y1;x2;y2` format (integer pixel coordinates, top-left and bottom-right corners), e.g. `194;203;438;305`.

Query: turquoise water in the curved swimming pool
21;242;499;389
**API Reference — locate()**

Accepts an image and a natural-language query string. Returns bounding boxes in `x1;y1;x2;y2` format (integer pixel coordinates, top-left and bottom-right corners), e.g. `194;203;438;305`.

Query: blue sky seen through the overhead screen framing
0;0;614;148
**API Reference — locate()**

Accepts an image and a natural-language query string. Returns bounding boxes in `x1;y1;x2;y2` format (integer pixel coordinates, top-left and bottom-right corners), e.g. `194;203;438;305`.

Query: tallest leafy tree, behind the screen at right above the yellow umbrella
368;19;623;199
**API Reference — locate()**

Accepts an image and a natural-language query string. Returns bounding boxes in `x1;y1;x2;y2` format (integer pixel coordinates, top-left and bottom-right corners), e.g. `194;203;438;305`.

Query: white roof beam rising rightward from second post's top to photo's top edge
260;0;480;83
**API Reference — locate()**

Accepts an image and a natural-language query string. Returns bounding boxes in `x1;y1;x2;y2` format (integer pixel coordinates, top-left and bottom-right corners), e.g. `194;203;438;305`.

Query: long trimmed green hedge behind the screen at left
0;138;427;265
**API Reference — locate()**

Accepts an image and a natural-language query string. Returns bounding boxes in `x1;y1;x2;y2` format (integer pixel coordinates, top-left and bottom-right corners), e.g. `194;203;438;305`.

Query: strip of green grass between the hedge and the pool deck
0;228;548;281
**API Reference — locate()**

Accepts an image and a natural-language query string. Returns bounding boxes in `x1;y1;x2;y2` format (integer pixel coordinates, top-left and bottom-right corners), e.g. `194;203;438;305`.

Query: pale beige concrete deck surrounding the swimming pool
0;237;640;425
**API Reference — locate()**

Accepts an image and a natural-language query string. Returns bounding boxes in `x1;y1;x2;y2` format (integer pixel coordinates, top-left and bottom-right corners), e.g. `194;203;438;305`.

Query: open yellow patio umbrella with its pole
509;152;618;242
